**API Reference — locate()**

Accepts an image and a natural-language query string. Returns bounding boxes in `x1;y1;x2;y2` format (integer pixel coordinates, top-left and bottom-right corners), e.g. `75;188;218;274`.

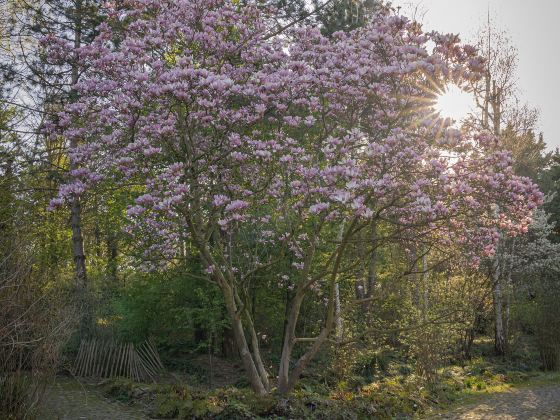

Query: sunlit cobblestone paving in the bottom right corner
436;385;560;420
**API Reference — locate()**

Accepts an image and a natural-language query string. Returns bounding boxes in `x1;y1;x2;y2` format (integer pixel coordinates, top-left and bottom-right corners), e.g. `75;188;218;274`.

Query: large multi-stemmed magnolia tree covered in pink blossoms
49;0;540;393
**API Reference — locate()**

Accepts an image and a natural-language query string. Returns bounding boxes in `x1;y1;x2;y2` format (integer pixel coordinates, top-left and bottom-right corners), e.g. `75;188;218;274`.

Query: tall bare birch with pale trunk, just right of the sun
467;17;551;355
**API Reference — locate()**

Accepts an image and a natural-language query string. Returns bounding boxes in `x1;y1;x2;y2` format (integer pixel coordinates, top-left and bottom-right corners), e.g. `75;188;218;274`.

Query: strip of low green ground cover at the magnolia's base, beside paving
99;358;560;419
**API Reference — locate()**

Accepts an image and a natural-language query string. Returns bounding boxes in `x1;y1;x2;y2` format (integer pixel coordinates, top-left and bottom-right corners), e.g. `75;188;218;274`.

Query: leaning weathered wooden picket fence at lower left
73;339;165;382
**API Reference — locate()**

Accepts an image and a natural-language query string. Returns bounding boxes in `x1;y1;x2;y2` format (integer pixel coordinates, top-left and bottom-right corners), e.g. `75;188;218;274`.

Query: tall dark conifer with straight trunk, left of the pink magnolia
5;0;102;334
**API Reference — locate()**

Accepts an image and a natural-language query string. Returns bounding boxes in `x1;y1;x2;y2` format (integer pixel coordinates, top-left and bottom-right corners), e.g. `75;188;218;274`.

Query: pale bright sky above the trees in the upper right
392;0;560;149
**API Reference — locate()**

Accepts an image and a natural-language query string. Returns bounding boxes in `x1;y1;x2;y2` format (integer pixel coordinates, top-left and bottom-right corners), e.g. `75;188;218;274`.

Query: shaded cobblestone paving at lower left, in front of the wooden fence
38;377;148;420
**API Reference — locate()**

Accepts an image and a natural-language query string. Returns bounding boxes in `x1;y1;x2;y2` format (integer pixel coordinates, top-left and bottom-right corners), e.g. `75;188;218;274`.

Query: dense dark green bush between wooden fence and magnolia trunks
107;271;229;362
